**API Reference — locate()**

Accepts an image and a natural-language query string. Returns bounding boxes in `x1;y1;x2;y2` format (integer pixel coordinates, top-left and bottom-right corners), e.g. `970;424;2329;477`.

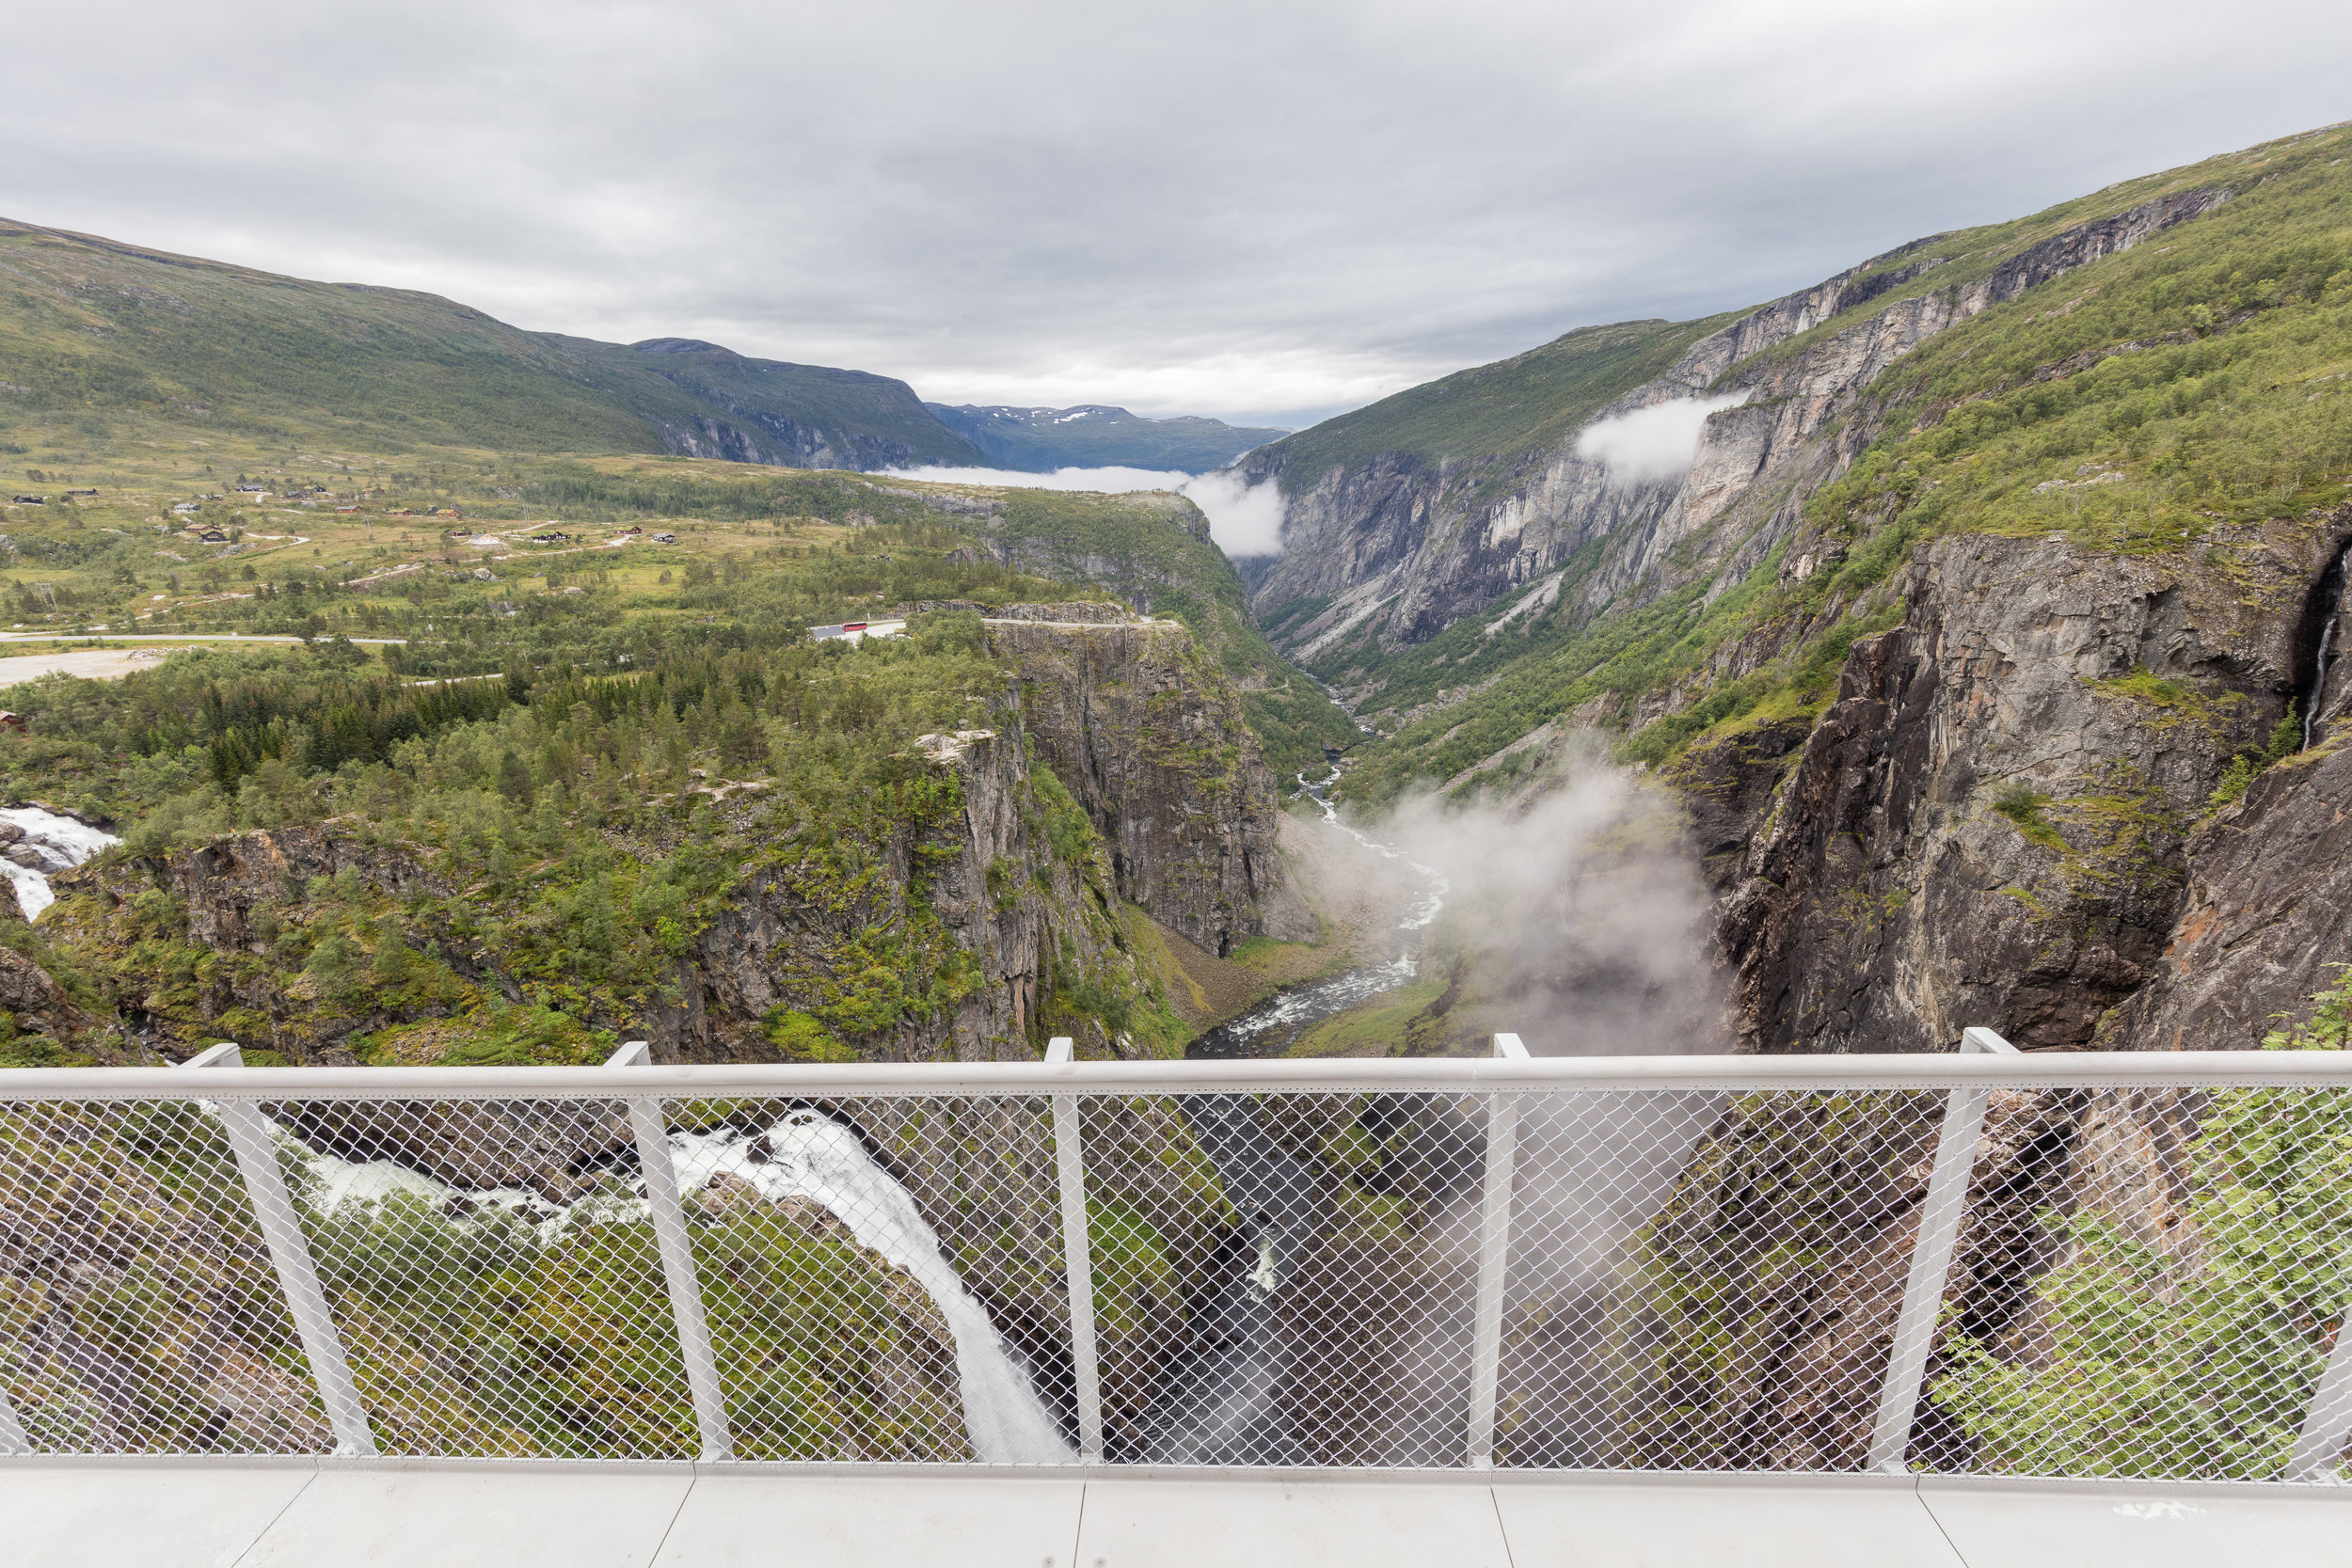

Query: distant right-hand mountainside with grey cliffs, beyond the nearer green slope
1240;136;2341;792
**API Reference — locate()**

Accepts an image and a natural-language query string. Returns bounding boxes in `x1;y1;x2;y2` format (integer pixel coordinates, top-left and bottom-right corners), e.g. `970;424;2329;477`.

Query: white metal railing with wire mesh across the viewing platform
0;1030;2352;1481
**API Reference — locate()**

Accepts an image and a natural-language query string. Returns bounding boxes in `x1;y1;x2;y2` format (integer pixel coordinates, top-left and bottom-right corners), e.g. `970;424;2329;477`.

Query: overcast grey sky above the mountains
0;0;2352;425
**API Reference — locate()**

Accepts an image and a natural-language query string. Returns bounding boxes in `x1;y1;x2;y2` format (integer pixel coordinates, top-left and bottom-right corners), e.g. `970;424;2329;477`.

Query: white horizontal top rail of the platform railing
0;1051;2352;1101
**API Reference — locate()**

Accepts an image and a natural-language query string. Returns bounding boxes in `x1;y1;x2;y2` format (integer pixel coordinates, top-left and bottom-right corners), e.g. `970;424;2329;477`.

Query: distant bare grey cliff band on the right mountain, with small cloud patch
1242;188;2233;663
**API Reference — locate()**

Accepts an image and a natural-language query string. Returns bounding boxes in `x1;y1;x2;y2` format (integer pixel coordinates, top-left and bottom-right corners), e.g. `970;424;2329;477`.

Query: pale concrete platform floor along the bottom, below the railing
0;1458;2352;1568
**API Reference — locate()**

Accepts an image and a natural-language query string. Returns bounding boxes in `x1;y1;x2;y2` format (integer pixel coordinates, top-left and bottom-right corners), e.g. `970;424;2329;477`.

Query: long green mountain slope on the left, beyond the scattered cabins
0;221;981;467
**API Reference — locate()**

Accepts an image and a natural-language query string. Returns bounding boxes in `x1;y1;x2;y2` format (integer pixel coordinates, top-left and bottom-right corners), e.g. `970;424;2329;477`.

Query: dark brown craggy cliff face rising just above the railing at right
1689;527;2333;1051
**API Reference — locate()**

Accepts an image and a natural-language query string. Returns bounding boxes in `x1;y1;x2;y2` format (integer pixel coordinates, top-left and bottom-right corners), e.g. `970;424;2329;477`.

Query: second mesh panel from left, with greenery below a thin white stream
263;1101;699;1460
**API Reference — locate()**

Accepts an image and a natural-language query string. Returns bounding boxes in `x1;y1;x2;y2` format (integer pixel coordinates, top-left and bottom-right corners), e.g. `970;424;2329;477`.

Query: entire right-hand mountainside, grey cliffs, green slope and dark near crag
1245;116;2352;1067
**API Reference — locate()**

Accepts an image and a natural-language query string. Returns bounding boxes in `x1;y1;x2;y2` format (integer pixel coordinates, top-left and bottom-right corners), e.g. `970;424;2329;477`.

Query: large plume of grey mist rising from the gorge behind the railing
1336;748;1726;1465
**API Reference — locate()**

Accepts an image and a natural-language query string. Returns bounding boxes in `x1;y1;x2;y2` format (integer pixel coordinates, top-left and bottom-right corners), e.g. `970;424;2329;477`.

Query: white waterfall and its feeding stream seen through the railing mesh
280;1110;1077;1465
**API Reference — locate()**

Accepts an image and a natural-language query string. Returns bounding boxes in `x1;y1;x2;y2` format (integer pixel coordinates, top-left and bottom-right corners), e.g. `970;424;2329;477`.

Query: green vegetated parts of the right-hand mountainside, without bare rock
1261;129;2352;800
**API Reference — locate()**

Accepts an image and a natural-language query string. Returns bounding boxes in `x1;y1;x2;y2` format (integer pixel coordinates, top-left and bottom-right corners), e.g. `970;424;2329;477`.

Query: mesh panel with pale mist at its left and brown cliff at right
1496;1091;1946;1472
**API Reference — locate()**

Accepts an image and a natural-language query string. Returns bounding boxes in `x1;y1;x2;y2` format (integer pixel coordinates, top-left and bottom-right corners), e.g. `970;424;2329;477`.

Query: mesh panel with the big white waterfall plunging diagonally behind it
671;1096;1075;1465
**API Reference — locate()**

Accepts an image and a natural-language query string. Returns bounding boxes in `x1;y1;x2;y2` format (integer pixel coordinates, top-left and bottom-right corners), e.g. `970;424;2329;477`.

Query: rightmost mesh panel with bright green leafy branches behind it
1915;1088;2352;1481
